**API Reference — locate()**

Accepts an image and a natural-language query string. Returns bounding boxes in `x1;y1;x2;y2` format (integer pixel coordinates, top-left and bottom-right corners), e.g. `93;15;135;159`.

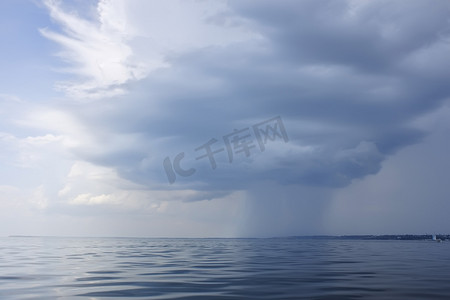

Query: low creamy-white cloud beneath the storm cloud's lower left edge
58;161;229;214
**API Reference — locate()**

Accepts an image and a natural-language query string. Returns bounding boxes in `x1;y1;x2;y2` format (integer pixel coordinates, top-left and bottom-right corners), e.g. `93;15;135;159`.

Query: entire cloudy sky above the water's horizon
0;0;450;237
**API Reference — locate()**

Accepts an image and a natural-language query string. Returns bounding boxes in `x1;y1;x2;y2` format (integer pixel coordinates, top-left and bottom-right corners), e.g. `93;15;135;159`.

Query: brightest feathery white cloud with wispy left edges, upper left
41;0;147;99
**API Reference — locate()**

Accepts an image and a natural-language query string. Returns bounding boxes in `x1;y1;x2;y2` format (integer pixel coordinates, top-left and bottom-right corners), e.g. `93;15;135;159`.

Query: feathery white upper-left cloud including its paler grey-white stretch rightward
41;0;260;99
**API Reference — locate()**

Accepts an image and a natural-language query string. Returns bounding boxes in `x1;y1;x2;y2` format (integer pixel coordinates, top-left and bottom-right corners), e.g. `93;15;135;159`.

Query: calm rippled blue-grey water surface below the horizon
0;237;450;299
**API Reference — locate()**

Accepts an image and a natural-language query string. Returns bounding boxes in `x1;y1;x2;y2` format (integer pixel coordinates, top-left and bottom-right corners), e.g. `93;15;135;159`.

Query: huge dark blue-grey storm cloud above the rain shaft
59;1;450;195
